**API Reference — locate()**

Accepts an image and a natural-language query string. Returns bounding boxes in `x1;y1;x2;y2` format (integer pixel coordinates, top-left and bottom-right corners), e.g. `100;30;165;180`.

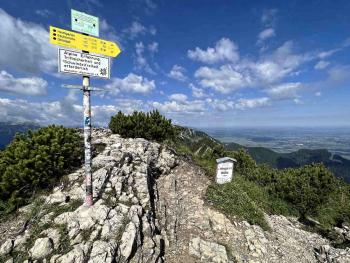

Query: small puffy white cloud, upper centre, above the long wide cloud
187;38;239;64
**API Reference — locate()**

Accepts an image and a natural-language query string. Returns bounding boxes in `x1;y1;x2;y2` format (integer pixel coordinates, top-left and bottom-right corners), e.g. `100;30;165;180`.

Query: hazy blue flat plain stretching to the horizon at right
201;127;350;159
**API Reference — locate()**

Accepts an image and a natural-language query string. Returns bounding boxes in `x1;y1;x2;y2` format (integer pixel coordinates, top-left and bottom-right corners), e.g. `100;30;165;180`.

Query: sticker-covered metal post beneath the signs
83;76;93;206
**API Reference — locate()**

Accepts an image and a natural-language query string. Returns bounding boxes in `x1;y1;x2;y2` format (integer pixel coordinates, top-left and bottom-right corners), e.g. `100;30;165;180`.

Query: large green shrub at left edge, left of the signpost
0;125;83;213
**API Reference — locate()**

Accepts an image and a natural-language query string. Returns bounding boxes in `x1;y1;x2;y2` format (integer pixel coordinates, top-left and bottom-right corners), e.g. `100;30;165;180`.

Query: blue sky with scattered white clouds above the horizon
0;0;350;128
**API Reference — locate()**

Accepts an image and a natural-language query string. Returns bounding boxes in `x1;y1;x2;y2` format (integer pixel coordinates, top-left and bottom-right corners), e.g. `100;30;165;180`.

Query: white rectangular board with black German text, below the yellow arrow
58;49;110;79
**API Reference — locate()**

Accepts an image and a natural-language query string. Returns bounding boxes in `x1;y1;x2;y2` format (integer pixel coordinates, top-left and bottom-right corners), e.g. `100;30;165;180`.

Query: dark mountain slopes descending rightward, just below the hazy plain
180;128;350;183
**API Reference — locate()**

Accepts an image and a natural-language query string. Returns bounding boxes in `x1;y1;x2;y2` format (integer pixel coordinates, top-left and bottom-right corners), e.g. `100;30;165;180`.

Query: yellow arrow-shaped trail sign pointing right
50;26;120;57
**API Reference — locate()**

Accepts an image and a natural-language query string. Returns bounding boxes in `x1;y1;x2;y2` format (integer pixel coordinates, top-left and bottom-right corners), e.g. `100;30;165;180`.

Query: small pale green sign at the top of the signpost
71;9;99;37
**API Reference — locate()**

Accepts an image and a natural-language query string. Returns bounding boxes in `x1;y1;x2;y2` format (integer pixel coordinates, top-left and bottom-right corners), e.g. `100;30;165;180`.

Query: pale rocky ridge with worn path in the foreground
0;129;350;263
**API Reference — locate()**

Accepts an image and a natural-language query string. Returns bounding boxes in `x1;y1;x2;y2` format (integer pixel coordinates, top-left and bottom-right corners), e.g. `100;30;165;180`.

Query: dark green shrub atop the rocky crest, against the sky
109;111;177;142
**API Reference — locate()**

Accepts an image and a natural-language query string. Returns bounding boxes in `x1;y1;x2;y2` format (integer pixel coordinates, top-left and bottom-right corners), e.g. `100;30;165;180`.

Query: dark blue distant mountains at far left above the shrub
0;122;40;150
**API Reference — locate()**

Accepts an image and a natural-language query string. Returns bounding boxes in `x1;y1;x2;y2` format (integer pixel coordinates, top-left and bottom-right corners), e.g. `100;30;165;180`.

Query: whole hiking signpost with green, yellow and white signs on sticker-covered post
50;9;121;207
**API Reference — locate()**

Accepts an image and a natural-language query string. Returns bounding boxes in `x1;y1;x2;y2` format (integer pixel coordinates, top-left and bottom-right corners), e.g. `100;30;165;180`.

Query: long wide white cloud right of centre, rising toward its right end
194;41;315;94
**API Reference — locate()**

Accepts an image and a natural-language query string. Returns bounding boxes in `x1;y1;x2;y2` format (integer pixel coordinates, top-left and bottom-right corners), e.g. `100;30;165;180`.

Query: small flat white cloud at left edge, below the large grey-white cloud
0;70;47;96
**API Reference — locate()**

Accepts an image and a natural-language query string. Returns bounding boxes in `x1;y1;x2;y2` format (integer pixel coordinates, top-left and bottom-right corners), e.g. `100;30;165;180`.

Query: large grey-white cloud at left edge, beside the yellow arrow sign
0;8;57;73
